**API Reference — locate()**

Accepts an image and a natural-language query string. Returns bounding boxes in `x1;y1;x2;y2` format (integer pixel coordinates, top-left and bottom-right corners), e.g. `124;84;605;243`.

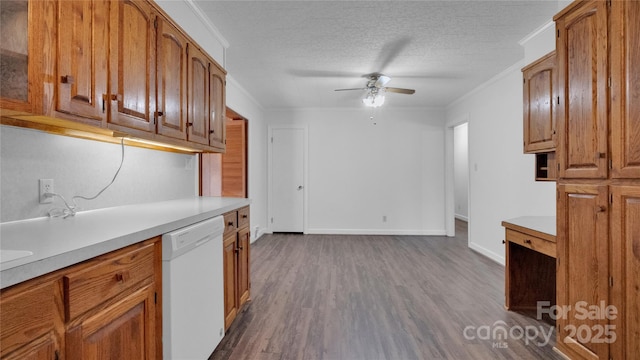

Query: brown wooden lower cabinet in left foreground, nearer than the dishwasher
0;237;162;360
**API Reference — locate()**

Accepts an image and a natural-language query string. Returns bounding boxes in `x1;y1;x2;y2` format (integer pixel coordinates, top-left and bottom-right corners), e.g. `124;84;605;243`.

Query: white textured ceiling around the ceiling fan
193;0;558;109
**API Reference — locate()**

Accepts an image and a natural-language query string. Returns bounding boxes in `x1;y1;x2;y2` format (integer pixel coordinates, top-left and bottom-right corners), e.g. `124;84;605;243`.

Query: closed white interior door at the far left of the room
270;128;305;232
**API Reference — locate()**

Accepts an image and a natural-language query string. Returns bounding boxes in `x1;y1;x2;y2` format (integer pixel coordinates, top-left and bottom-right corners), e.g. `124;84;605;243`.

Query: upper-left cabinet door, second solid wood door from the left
109;0;156;132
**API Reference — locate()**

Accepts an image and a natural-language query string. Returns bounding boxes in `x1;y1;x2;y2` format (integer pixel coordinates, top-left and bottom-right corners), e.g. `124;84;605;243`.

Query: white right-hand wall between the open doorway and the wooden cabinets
447;64;555;264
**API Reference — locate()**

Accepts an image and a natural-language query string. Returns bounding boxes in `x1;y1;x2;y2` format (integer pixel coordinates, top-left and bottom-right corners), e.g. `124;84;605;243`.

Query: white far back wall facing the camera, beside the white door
267;107;444;235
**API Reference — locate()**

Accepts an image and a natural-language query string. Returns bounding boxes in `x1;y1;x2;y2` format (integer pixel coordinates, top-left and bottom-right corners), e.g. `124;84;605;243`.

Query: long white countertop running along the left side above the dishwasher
0;196;251;288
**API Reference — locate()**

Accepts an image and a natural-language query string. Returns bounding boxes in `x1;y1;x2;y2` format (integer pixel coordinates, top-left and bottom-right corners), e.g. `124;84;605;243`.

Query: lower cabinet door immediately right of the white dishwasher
222;232;238;329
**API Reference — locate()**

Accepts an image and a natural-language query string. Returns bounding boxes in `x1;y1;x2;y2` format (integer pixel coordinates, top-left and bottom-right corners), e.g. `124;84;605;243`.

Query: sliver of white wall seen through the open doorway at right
453;123;469;221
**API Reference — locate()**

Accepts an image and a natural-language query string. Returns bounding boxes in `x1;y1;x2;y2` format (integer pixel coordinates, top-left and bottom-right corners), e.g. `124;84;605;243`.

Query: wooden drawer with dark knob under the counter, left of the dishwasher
63;244;155;321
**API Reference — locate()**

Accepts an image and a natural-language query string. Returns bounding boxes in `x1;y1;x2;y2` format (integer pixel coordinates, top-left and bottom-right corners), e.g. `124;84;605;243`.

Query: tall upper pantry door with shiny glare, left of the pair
556;0;609;179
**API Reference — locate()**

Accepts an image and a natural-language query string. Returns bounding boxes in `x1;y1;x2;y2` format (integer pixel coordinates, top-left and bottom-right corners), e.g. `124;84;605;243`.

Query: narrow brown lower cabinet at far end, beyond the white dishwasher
223;206;251;329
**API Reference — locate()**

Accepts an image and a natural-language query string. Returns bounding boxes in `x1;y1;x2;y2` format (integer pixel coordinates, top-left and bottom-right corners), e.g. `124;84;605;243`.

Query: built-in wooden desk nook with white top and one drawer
502;216;556;316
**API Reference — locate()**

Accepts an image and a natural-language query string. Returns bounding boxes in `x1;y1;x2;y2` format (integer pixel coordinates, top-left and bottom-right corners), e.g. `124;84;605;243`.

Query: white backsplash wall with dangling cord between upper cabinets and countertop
0;126;198;222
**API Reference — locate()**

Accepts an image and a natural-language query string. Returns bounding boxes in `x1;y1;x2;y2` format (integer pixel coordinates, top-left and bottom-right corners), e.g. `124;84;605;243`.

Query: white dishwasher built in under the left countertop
162;216;224;360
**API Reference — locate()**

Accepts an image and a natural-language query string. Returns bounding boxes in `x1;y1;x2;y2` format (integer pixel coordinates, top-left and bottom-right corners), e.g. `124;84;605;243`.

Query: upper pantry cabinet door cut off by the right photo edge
611;1;640;179
